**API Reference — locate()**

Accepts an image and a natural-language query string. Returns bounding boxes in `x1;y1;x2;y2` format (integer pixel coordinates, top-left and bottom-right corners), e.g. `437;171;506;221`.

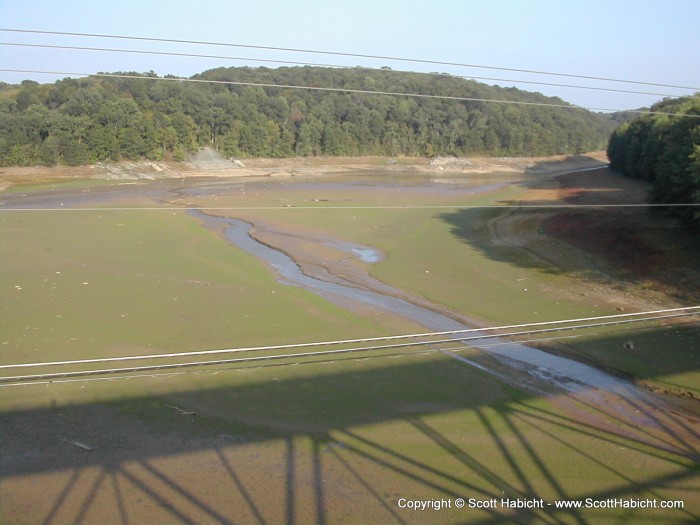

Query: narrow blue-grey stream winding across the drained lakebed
190;210;640;398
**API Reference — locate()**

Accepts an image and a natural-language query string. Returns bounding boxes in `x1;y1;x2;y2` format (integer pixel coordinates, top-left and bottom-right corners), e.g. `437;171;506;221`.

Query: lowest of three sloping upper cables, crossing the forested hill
0;69;700;118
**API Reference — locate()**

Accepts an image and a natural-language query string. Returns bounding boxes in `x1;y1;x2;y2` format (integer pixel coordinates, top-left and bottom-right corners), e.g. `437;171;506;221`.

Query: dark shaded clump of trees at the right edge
608;95;700;229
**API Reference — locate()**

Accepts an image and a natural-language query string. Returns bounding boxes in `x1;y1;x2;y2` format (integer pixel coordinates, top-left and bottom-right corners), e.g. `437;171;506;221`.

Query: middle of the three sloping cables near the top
0;42;680;98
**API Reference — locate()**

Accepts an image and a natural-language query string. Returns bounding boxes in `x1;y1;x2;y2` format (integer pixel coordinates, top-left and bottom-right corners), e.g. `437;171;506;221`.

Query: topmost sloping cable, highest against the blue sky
0;28;700;91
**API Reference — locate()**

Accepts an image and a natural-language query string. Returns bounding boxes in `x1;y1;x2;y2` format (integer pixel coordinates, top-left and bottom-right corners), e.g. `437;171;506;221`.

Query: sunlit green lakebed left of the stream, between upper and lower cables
0;210;424;404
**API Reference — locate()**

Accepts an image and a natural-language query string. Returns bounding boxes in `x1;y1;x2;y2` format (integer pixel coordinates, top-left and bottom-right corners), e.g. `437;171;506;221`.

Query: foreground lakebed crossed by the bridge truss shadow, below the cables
0;338;700;525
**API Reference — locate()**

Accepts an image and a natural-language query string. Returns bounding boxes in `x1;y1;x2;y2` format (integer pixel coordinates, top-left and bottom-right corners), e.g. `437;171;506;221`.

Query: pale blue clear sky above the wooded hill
0;0;700;110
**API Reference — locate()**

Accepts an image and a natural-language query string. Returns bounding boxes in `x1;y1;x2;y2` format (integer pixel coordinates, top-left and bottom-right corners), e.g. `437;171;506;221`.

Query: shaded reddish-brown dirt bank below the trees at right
525;168;700;306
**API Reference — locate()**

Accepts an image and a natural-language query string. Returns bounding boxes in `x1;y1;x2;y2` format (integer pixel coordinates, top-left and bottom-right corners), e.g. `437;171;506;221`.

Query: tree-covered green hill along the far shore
0;66;615;165
